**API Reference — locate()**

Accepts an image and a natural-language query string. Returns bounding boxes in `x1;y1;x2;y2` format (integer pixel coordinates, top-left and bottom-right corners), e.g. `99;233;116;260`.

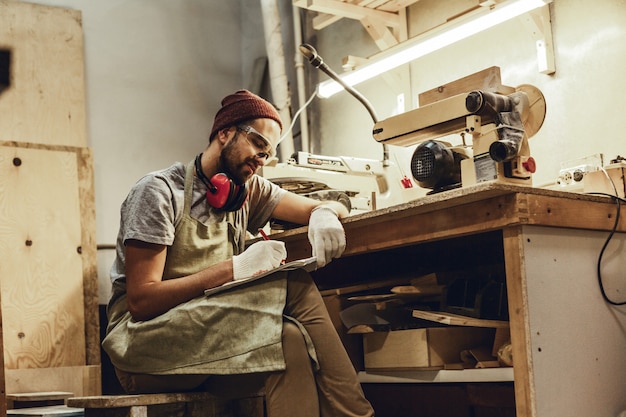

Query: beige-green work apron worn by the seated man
103;159;286;374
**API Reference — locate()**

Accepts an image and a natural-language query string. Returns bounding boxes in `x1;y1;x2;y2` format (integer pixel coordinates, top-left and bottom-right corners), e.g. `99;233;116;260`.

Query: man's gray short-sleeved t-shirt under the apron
111;162;287;298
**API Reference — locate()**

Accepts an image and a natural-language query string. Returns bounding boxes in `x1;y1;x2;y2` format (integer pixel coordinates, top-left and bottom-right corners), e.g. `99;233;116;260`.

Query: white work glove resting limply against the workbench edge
309;205;346;268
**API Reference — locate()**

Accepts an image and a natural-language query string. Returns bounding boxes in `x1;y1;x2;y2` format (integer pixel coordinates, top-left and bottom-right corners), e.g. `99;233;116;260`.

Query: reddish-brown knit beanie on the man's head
209;90;283;140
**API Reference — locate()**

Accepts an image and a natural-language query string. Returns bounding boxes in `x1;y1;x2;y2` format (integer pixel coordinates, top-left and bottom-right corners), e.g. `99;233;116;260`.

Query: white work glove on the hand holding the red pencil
233;240;287;281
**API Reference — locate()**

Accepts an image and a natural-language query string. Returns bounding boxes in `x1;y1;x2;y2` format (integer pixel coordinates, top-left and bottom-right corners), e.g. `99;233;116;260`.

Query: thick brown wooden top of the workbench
272;183;626;259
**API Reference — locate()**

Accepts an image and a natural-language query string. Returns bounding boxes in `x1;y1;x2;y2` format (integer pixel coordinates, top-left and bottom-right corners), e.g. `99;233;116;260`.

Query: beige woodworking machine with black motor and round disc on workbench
373;85;546;192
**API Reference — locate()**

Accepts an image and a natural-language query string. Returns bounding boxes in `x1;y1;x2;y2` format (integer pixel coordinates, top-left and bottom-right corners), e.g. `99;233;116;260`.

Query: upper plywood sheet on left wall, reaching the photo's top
0;0;87;146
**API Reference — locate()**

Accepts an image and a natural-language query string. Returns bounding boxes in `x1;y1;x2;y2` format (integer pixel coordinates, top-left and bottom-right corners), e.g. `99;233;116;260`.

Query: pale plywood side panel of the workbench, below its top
520;226;626;417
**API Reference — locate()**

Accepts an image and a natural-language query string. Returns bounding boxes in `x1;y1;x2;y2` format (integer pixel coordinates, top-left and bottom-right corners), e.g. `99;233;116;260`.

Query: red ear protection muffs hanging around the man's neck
195;154;248;211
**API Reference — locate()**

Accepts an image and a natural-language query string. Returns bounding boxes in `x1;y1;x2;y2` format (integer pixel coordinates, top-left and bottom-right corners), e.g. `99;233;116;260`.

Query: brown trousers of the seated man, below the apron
117;270;374;417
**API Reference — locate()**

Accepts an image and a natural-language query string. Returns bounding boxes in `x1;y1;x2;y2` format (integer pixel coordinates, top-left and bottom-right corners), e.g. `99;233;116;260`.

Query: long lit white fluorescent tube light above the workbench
317;0;552;98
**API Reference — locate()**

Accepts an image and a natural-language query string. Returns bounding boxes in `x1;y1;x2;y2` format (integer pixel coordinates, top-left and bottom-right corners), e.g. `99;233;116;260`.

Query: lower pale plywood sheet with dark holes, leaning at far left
0;146;85;369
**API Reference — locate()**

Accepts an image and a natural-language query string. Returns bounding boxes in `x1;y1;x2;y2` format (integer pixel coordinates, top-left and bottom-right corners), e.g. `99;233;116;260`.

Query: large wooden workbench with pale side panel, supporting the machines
275;184;626;417
